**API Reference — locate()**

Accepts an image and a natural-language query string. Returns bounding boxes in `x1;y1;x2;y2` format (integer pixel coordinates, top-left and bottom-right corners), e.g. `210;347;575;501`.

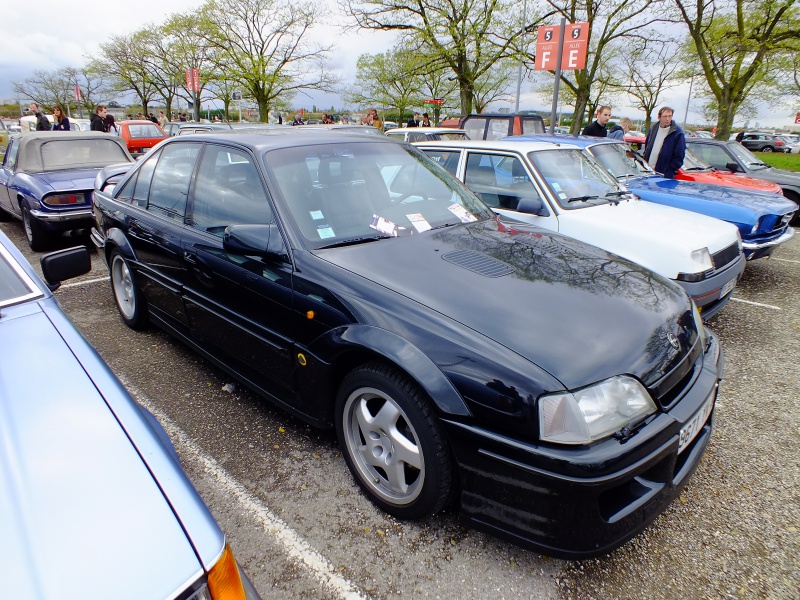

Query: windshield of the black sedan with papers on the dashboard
265;138;493;248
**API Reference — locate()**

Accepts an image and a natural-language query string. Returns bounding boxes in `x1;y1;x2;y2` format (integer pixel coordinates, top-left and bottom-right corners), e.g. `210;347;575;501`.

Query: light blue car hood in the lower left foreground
0;302;202;600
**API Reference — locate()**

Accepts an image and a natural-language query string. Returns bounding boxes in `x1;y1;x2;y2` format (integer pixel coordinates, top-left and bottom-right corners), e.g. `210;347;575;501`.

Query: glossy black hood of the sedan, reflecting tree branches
317;221;696;389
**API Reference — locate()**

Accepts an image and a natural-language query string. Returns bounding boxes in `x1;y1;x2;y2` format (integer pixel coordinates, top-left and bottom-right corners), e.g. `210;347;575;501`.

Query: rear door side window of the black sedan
145;144;200;221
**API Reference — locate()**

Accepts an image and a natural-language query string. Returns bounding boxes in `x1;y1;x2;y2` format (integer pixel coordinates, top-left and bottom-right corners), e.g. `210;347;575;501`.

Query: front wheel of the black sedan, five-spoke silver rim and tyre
336;362;453;519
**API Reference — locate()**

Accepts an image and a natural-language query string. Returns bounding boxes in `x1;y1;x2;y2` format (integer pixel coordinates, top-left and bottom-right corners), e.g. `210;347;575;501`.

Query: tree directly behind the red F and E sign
536;0;664;134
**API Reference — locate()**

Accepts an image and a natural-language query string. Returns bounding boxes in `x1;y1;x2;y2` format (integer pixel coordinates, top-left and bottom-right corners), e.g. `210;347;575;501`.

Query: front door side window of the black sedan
189;144;273;236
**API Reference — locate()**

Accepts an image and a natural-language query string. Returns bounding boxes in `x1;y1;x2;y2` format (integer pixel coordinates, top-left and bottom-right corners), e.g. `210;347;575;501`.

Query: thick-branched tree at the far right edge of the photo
673;0;800;140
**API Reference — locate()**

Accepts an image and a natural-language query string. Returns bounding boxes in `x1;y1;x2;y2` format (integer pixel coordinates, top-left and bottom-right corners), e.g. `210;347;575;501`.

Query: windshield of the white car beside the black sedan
528;148;627;210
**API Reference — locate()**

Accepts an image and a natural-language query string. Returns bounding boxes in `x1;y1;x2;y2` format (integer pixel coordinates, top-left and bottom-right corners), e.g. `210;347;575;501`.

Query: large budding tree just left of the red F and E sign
340;0;542;114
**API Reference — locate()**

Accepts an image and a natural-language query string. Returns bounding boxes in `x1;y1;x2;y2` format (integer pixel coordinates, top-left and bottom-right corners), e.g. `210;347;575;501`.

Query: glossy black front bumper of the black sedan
447;332;723;558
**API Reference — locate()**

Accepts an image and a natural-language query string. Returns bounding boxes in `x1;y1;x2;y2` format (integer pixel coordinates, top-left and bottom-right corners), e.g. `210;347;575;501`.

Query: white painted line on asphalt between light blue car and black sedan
123;380;368;600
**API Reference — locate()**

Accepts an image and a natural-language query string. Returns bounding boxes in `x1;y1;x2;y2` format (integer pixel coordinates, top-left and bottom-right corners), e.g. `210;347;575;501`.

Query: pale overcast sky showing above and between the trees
0;0;800;128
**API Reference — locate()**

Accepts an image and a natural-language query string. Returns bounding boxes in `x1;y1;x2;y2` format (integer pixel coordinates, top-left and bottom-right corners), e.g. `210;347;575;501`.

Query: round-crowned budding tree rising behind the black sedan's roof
198;0;337;122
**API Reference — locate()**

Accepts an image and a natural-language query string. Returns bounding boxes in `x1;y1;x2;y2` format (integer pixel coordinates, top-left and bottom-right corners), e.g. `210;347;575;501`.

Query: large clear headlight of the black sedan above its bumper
539;375;656;444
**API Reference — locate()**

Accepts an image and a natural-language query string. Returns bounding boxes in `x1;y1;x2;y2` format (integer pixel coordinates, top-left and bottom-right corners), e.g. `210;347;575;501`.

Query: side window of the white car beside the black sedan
464;152;539;210
